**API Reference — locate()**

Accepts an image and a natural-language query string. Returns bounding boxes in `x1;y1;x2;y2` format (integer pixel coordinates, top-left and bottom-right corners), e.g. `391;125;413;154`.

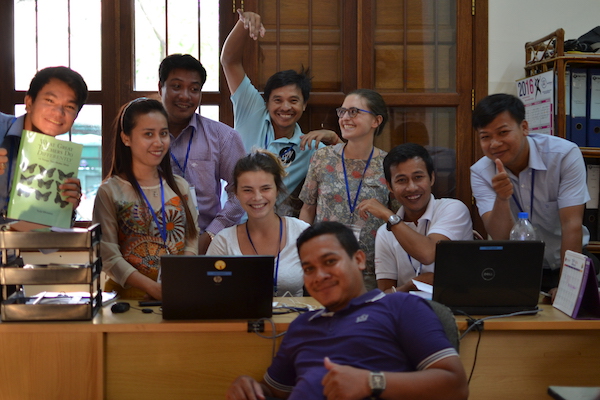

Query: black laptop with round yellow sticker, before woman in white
161;255;274;319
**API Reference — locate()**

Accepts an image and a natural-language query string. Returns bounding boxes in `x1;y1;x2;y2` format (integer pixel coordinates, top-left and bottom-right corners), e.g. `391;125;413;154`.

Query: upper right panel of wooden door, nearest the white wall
374;0;456;93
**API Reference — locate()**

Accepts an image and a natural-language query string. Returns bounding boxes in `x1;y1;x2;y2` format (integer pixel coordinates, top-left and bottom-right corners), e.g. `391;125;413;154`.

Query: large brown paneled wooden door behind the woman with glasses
230;0;487;219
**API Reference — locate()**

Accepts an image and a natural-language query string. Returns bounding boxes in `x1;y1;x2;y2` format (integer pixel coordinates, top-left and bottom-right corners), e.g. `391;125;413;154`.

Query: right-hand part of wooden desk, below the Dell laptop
457;305;600;400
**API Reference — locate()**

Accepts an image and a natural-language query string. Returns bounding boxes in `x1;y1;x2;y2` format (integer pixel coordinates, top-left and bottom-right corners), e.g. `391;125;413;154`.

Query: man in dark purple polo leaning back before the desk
227;222;468;400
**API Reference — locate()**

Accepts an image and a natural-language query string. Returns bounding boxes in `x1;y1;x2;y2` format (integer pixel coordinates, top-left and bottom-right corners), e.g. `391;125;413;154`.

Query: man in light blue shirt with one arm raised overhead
221;12;340;216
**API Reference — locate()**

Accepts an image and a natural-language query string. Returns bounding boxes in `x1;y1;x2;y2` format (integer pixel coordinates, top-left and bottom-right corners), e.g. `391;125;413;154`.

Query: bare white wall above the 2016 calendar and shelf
488;0;600;95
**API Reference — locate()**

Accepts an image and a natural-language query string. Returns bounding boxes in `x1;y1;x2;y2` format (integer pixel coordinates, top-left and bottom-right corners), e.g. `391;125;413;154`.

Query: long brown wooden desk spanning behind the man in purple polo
0;299;600;400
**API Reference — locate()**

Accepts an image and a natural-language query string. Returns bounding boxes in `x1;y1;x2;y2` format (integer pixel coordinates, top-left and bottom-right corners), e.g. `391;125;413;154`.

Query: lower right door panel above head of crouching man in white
375;107;456;198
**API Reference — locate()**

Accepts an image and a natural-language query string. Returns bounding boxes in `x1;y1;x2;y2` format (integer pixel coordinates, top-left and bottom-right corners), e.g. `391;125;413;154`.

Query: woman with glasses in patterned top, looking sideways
300;89;390;290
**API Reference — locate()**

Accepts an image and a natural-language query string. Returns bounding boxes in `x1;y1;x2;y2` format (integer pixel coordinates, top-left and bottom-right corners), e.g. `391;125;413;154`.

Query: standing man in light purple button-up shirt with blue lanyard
158;54;246;254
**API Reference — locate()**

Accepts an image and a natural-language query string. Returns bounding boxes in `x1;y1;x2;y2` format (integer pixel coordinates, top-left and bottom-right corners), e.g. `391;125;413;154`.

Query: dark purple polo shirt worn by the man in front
265;289;457;400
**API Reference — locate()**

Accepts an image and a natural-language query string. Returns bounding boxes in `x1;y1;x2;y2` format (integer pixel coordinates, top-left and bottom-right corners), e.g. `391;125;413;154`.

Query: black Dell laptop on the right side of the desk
433;240;544;315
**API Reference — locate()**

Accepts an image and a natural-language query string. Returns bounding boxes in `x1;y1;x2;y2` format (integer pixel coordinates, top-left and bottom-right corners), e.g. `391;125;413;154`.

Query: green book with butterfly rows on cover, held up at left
7;130;83;228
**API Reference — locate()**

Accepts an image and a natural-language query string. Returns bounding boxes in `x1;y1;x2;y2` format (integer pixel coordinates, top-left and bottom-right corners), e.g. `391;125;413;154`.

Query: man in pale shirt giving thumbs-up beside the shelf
471;94;590;290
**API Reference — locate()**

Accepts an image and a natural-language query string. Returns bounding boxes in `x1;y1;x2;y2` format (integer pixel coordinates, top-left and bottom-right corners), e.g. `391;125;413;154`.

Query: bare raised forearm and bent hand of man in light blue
221;10;265;94
